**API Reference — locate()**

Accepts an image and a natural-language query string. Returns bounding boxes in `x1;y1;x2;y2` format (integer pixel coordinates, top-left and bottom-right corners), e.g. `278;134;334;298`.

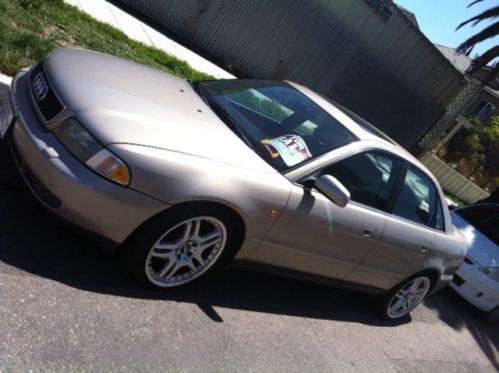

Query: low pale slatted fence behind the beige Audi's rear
421;153;489;204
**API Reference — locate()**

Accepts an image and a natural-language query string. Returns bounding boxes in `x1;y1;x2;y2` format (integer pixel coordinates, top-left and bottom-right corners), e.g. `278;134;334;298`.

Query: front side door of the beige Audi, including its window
249;151;401;279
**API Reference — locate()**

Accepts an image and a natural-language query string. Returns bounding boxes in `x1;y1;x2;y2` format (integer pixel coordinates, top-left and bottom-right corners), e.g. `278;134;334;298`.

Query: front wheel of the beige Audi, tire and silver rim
123;204;239;288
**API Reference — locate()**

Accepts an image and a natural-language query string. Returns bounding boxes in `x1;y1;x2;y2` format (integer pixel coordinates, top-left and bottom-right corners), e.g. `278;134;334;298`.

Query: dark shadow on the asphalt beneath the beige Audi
0;139;402;326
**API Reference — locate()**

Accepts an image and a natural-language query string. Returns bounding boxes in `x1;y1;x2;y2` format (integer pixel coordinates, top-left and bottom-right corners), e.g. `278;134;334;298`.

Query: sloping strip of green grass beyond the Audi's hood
0;0;212;80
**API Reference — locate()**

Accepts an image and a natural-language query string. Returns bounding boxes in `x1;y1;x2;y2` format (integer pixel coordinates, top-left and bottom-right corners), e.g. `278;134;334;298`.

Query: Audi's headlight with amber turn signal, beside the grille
54;118;130;185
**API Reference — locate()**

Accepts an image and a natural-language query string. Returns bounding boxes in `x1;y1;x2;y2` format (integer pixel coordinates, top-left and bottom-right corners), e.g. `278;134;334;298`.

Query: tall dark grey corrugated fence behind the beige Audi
109;0;466;149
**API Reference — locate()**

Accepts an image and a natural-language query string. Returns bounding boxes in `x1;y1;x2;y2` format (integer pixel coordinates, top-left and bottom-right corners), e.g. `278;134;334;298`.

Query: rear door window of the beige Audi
392;166;443;229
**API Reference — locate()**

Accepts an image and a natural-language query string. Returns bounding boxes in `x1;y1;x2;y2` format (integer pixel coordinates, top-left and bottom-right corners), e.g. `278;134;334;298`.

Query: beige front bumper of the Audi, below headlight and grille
6;72;169;243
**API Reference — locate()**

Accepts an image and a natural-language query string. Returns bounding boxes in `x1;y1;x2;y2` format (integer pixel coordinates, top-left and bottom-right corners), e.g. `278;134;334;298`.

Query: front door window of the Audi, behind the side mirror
322;151;401;210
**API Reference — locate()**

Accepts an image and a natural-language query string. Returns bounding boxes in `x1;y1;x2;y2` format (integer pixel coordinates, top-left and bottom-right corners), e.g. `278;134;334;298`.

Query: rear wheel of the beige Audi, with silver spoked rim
378;273;432;320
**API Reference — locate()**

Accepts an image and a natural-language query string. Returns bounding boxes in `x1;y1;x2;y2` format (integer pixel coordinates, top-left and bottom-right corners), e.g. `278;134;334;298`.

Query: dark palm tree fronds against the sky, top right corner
456;0;499;77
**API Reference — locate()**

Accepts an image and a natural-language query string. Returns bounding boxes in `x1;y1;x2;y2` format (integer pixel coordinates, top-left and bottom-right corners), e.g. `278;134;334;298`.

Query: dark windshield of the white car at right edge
454;204;499;245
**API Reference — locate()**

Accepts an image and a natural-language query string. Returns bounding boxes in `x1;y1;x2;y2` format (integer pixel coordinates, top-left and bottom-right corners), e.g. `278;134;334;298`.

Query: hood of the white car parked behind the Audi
451;211;499;267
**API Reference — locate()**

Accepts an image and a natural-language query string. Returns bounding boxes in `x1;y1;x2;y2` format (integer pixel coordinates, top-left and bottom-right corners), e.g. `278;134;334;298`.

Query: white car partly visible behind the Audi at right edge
450;203;499;321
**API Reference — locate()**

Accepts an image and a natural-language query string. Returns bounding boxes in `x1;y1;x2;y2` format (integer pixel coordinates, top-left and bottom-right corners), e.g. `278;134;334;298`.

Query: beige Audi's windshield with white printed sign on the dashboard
199;79;358;172
